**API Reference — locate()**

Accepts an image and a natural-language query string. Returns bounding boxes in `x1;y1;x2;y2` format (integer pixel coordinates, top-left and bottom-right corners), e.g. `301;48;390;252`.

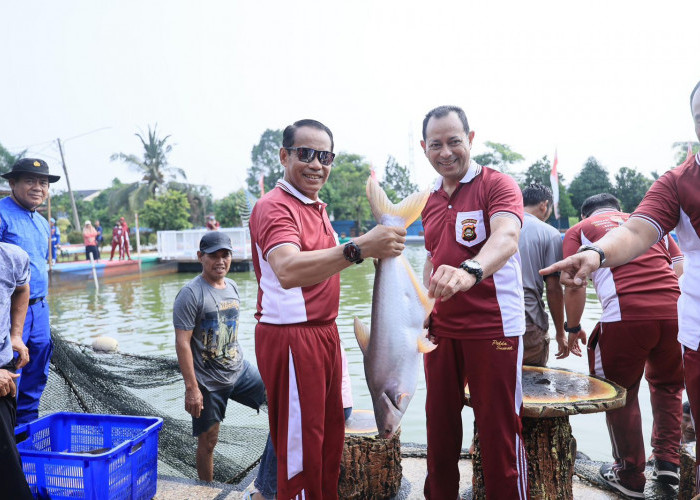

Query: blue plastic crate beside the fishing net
15;413;163;500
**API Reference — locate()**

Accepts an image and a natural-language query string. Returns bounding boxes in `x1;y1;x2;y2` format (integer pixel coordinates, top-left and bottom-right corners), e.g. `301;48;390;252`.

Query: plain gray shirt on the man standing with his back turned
518;212;562;330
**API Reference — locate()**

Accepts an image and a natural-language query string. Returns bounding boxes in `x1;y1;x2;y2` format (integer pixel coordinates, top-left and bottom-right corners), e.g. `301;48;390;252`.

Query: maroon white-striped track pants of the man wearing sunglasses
255;322;345;500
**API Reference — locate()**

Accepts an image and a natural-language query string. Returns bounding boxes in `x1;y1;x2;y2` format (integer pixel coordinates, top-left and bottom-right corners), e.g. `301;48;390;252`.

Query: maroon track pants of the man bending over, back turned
588;319;683;489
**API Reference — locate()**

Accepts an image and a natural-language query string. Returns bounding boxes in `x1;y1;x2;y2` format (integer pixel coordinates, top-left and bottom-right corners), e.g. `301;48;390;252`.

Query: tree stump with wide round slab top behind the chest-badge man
465;366;626;500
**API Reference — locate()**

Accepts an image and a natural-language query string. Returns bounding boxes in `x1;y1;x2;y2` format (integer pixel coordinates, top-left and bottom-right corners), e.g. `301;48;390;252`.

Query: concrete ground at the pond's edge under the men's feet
155;458;623;500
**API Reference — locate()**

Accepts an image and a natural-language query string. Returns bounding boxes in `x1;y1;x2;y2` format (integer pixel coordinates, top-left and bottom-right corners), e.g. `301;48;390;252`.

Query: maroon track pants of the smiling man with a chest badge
423;337;529;500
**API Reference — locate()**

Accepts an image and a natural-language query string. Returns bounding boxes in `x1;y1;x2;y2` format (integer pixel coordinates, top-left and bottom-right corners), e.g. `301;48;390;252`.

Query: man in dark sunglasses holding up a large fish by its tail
250;120;406;500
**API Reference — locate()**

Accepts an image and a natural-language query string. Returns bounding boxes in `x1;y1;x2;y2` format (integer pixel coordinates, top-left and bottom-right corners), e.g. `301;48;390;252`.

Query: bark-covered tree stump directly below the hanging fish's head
338;410;403;500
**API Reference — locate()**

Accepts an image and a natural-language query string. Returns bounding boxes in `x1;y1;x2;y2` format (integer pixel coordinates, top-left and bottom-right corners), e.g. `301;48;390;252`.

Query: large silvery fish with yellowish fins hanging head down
355;178;437;438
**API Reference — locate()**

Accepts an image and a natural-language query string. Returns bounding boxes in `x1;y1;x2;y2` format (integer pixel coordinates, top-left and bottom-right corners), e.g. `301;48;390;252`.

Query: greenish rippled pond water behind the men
49;246;664;460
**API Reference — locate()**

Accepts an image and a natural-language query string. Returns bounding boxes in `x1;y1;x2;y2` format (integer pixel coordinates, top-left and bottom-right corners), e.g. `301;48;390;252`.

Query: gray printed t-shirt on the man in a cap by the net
173;274;243;391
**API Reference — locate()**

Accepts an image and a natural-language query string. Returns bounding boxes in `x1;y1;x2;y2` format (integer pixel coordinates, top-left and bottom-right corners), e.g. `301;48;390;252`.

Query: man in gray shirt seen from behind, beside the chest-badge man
518;183;569;366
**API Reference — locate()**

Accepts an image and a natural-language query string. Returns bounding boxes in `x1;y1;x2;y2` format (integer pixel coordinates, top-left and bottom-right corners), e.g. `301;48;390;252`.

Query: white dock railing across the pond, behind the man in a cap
158;227;252;261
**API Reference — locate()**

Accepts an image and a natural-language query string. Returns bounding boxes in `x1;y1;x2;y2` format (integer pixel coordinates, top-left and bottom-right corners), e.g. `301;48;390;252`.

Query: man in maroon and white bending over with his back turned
564;193;683;498
